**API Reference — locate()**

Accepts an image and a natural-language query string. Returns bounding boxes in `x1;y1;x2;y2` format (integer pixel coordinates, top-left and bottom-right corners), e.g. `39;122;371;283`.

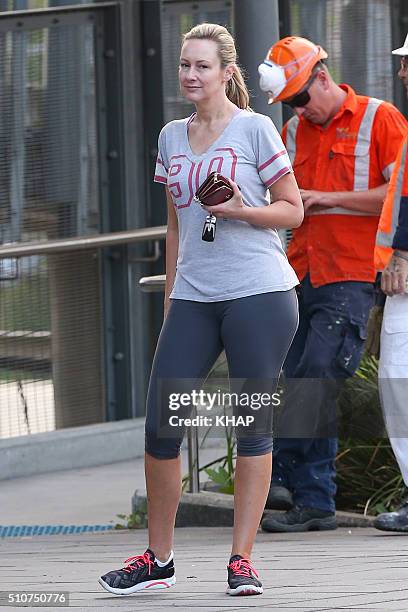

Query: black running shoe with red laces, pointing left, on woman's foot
99;549;176;595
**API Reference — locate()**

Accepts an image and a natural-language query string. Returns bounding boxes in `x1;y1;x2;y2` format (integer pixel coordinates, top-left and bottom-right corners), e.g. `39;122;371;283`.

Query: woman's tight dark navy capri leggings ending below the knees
145;289;298;459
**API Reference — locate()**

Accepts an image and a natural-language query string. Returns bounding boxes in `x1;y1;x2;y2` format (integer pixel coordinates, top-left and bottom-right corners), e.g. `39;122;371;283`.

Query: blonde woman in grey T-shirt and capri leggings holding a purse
100;23;303;595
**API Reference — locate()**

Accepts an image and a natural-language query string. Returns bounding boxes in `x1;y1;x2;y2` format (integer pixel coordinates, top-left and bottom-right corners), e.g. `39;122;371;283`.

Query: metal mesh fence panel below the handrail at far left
0;251;104;438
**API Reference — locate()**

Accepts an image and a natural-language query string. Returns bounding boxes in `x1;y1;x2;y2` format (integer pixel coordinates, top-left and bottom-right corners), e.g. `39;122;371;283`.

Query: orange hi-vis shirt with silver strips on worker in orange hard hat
282;85;408;287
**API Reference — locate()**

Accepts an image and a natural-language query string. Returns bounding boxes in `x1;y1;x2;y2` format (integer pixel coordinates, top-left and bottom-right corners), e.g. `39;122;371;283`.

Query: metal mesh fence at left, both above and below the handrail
0;11;105;437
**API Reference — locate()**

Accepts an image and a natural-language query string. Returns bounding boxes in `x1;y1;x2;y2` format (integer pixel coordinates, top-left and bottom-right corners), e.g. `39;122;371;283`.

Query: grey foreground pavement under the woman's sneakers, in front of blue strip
0;528;408;612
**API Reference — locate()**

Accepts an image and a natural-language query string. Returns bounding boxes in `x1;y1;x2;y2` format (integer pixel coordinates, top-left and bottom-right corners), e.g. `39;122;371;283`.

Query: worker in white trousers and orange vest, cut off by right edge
374;36;408;532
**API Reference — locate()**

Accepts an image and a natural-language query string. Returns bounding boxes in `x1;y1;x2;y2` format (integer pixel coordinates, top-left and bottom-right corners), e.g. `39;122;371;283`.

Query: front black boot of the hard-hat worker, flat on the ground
261;506;337;533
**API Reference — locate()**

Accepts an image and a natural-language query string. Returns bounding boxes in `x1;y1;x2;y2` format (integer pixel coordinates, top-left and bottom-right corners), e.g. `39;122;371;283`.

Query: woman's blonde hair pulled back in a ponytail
183;23;251;110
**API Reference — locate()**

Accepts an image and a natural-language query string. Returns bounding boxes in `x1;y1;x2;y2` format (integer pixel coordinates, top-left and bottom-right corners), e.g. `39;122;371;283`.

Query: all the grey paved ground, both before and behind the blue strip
0;449;408;612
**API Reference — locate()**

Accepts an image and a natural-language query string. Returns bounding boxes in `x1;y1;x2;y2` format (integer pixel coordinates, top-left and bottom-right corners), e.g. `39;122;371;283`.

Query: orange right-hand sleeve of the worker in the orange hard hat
373;102;408;182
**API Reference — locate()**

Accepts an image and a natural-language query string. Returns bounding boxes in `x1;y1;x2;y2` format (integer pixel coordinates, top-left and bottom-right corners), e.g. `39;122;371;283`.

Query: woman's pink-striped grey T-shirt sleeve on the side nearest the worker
255;115;292;187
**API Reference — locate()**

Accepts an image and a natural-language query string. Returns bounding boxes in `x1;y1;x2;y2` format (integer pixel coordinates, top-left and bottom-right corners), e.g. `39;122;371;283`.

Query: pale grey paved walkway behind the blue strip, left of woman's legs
0;448;223;525
